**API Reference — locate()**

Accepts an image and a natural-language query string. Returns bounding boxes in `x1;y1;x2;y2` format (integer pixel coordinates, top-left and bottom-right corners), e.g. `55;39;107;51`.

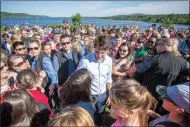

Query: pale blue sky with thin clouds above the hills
1;1;189;17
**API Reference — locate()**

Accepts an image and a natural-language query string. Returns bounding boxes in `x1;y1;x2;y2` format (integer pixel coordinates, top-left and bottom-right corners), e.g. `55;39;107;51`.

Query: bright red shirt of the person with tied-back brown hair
29;90;54;118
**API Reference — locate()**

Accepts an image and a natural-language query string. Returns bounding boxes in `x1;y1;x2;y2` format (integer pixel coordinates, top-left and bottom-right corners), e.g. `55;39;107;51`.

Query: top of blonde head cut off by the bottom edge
48;106;94;127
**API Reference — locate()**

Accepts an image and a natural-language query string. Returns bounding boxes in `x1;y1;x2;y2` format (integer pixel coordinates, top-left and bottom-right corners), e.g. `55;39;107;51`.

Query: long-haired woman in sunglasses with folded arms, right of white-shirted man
112;43;133;81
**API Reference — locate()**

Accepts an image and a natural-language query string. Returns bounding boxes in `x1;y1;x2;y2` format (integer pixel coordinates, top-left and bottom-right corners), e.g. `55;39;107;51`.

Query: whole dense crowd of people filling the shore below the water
0;21;190;127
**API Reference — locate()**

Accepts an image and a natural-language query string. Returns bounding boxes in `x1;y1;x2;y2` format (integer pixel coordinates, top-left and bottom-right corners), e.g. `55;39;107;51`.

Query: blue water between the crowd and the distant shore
1;17;189;29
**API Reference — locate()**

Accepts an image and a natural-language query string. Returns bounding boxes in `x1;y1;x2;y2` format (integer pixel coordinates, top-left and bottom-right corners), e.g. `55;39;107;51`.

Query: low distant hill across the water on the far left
1;12;48;18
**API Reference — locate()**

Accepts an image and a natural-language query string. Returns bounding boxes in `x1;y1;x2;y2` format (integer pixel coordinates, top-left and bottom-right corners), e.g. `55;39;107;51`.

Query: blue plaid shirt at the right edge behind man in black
178;40;190;54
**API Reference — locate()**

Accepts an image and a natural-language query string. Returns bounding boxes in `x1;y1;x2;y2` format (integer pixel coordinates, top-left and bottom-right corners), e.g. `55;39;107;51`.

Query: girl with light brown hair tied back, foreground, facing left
109;79;157;127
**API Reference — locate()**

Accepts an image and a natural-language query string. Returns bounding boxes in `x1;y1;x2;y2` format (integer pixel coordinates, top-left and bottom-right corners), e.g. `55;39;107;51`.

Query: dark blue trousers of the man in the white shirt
91;92;107;126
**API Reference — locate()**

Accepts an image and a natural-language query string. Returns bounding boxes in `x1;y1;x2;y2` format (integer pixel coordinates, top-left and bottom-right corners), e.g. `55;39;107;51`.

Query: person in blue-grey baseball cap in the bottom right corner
149;82;190;127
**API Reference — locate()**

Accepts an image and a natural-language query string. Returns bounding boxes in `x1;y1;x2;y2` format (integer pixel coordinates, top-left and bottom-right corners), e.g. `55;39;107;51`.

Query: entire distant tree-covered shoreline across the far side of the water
1;12;190;25
